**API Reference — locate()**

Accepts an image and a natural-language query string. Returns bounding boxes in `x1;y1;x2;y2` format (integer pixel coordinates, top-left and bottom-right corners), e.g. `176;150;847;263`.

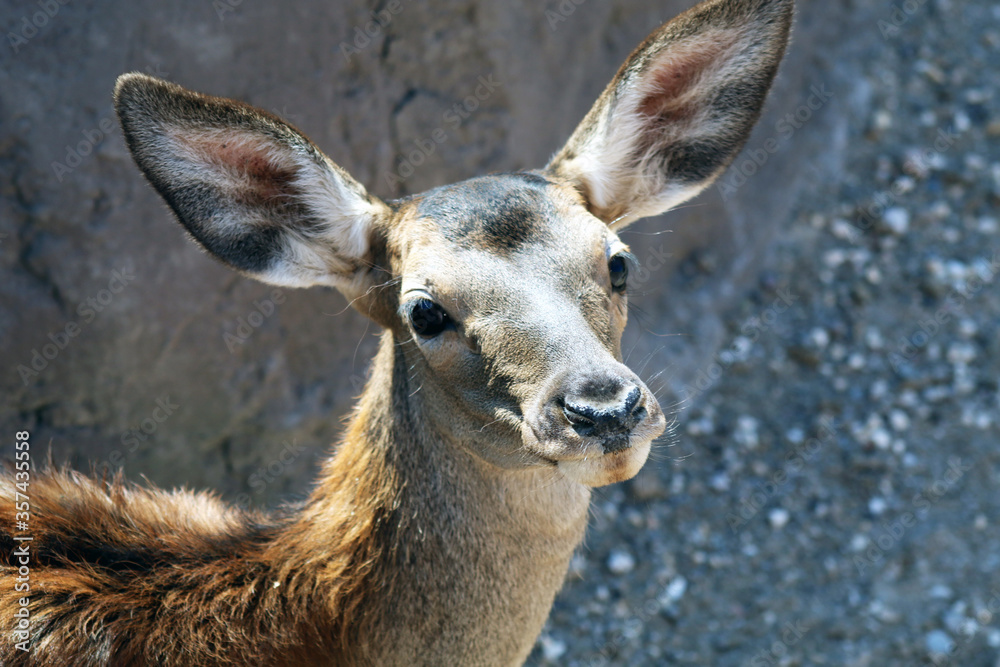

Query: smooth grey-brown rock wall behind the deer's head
0;0;864;504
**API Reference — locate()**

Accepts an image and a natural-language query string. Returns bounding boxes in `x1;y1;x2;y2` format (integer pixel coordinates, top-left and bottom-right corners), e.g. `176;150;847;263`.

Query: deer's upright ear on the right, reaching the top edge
546;0;793;228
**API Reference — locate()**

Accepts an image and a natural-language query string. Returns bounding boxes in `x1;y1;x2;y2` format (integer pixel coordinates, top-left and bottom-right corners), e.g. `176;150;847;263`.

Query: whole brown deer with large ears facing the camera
0;0;793;666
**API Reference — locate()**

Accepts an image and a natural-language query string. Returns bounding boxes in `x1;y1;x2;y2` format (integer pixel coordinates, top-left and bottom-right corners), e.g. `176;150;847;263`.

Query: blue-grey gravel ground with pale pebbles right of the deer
529;0;1000;666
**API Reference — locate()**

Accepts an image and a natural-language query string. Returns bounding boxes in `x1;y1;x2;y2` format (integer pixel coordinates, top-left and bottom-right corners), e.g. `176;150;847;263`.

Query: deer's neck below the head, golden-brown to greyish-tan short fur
273;331;590;664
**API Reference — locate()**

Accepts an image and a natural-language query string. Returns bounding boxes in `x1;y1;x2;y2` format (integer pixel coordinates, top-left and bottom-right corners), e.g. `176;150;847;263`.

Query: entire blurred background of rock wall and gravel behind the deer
0;0;1000;667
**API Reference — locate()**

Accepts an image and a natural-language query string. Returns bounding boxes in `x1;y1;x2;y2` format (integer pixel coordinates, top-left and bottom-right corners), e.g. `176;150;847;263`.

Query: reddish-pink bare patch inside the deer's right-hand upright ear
638;30;739;123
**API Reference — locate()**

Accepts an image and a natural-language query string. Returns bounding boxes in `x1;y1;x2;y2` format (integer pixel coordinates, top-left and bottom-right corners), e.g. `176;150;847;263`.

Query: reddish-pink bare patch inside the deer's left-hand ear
175;133;298;204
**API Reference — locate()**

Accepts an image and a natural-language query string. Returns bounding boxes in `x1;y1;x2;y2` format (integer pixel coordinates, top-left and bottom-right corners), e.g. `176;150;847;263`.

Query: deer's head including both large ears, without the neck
115;0;792;486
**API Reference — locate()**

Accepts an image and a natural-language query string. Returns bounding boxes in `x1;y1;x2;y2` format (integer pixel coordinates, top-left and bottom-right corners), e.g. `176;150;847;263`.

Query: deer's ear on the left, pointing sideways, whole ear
115;73;389;294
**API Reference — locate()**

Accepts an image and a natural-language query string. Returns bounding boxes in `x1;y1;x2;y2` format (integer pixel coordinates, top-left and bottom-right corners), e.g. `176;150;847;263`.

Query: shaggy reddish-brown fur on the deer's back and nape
0;374;399;666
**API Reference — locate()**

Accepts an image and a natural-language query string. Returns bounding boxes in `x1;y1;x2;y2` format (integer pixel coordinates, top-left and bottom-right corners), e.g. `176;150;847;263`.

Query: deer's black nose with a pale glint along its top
563;385;646;454
